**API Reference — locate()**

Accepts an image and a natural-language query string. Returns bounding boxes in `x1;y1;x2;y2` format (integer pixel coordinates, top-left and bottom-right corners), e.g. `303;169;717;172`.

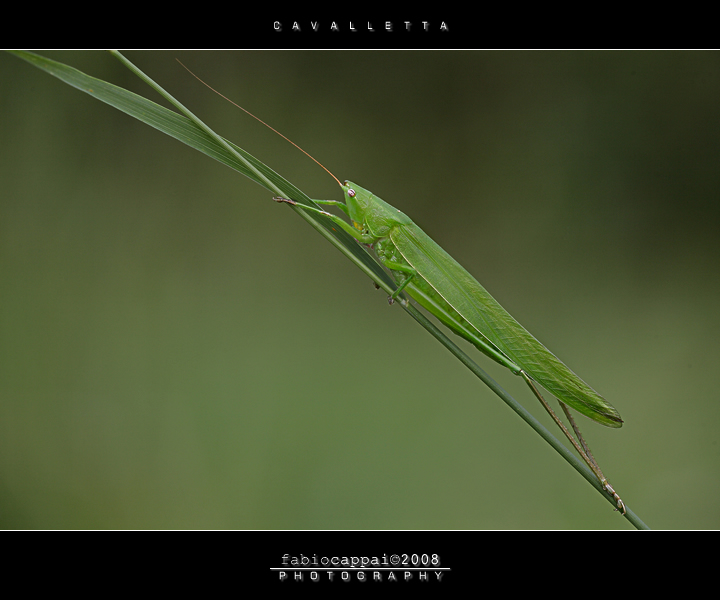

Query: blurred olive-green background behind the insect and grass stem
0;51;720;529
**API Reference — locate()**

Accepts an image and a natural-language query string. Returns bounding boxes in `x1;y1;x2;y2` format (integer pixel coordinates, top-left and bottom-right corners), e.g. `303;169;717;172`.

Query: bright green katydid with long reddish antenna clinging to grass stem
181;63;626;514
